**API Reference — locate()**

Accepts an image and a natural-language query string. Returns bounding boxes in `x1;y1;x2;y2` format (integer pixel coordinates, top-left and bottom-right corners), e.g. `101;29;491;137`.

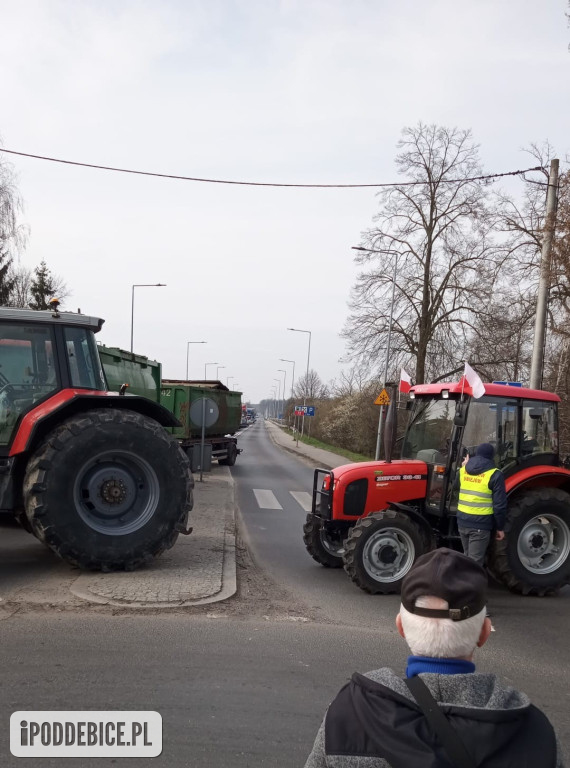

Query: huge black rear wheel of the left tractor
24;408;194;571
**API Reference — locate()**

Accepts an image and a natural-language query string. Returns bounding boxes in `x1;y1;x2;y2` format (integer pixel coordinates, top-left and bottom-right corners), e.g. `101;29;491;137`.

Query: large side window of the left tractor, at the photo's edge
0;323;59;446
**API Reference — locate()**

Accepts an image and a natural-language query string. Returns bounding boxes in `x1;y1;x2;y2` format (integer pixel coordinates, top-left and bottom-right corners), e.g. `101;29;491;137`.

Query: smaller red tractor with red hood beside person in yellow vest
303;383;570;595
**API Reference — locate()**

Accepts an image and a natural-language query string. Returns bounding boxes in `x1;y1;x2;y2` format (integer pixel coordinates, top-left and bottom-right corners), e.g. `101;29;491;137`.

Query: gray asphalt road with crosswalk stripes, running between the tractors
0;422;570;768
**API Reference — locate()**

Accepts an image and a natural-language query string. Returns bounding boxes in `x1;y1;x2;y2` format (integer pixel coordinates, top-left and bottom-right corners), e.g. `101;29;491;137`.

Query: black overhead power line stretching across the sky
0;147;544;189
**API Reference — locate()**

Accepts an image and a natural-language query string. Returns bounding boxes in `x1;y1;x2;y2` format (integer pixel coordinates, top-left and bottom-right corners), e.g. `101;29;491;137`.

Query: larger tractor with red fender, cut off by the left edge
0;302;193;571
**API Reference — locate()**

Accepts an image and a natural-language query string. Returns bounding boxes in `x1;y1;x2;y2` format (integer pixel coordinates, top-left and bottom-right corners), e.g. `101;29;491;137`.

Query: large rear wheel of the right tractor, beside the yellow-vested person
488;488;570;597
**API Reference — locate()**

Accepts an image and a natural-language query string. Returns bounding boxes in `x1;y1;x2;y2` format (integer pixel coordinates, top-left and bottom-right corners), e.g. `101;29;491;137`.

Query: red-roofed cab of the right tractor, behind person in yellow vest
401;384;560;516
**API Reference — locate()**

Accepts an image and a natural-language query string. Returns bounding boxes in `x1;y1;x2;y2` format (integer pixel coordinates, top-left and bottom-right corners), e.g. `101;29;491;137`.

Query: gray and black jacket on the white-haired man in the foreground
305;668;564;768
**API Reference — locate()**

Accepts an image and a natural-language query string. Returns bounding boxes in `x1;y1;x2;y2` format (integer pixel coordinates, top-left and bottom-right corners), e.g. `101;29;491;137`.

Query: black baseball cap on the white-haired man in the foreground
401;547;487;621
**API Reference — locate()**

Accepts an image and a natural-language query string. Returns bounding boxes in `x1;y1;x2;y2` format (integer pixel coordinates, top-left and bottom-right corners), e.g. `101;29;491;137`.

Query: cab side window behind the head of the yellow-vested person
463;397;518;469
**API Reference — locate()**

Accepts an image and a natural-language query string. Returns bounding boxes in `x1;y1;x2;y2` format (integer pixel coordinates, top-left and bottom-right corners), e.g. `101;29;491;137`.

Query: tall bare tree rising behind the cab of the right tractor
343;123;498;383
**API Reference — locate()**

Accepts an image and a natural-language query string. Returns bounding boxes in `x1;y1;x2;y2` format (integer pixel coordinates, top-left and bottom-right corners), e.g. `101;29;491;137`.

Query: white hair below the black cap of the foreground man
400;596;487;659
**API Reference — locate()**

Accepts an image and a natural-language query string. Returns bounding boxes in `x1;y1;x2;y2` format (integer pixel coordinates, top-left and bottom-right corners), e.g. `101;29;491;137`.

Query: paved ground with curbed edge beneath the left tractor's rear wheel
0;465;237;610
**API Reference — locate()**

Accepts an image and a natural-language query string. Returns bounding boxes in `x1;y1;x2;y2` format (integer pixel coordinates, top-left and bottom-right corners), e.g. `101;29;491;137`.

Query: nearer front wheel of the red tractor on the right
344;509;432;595
